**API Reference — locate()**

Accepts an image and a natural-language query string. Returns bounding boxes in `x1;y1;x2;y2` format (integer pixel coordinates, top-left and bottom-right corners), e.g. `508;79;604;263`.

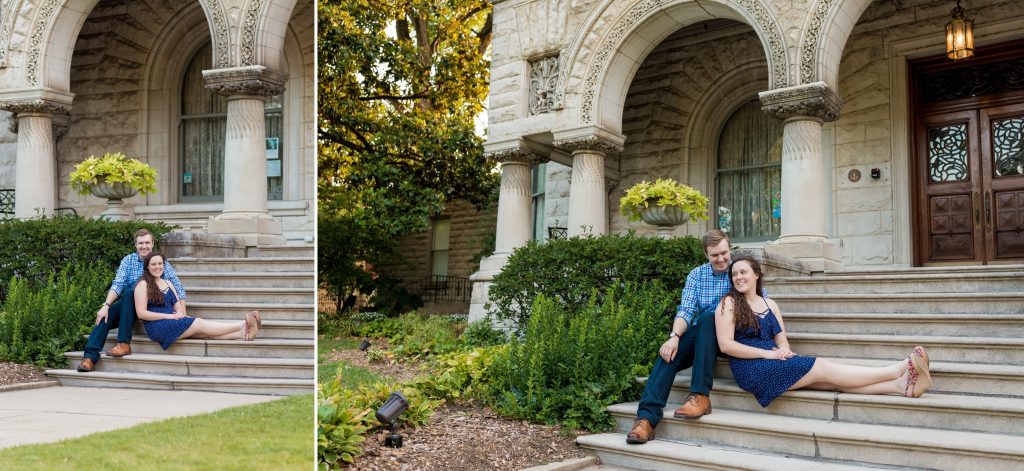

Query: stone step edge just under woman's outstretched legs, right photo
672;377;1024;415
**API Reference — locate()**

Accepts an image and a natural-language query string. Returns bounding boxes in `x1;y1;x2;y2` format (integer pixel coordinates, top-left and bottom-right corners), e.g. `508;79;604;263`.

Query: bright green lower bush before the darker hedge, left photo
0;264;114;368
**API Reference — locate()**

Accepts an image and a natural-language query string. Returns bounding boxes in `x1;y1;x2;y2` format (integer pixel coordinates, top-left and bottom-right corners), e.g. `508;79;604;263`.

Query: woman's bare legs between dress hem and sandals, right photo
790;358;907;394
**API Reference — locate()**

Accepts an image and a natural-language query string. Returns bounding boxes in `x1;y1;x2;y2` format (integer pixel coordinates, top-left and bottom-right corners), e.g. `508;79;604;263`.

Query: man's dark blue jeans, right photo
637;307;719;427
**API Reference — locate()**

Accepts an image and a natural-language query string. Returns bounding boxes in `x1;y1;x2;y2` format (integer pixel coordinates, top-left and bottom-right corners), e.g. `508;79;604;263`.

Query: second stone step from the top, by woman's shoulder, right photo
767;292;1024;314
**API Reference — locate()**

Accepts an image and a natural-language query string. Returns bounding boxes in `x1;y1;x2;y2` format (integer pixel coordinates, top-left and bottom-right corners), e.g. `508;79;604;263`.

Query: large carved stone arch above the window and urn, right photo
561;0;790;132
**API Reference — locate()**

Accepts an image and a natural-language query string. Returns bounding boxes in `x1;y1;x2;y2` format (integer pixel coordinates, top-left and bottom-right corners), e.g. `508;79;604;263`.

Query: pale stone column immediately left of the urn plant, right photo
555;135;623;237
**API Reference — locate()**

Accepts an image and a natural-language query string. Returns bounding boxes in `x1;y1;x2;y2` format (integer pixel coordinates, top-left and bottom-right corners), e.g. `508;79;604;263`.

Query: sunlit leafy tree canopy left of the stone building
317;0;498;305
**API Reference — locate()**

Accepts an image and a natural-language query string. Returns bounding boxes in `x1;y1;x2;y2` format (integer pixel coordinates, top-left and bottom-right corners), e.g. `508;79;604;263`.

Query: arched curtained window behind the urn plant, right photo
716;99;782;242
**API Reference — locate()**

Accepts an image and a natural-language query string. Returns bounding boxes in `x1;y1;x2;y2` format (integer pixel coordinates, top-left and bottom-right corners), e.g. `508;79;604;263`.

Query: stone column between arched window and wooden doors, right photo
760;82;843;271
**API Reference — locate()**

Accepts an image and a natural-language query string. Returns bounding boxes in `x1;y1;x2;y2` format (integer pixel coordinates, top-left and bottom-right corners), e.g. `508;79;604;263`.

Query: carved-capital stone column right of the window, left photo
203;66;288;247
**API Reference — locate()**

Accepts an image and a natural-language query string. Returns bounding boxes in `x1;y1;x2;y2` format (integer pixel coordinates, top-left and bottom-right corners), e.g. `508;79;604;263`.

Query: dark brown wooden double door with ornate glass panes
913;101;1024;264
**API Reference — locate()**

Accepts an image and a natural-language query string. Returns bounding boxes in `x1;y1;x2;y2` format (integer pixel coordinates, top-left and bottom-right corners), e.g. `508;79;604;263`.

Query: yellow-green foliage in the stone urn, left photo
71;153;157;195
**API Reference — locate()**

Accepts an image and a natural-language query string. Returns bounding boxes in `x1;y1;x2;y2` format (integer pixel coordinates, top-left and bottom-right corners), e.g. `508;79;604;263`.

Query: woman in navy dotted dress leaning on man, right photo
715;255;932;408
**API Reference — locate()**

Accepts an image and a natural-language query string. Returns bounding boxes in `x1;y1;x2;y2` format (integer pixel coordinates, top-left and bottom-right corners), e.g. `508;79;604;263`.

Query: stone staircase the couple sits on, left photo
46;246;315;394
